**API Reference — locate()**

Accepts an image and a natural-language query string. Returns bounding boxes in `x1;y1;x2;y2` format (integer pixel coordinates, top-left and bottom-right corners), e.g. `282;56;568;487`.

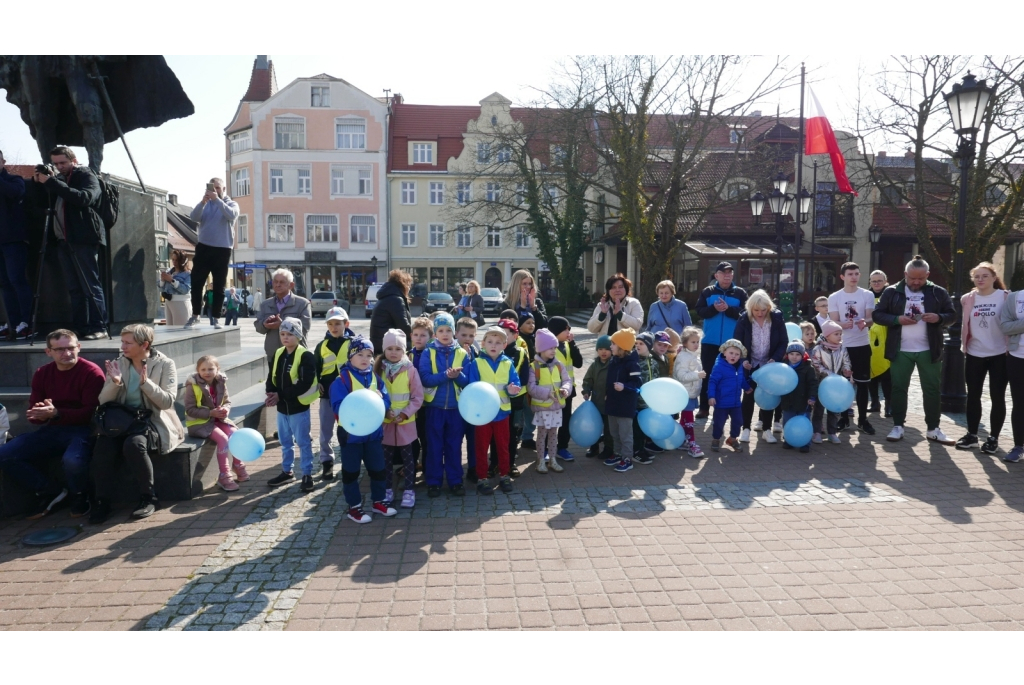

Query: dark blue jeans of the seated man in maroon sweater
0;426;92;493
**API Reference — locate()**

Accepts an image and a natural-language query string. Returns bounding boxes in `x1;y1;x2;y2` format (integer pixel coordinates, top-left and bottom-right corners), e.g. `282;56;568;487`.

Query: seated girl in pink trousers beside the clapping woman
182;354;241;493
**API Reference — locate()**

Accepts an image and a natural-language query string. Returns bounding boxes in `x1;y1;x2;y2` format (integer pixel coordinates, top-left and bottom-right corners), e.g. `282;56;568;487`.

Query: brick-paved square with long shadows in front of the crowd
0;321;1024;630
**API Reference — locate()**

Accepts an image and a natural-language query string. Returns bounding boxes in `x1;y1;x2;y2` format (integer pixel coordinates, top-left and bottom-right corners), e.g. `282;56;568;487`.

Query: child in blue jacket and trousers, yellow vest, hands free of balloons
417;312;469;498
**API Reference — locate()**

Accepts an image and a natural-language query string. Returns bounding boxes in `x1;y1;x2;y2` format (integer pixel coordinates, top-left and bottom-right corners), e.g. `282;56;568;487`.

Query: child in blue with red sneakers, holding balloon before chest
331;336;398;523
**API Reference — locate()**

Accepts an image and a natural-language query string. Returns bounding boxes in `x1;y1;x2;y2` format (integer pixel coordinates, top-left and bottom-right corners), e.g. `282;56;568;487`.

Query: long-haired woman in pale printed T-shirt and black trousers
956;262;1009;455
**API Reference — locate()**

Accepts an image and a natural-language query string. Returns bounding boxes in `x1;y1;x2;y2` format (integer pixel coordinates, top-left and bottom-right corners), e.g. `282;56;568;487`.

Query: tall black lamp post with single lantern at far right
941;72;994;413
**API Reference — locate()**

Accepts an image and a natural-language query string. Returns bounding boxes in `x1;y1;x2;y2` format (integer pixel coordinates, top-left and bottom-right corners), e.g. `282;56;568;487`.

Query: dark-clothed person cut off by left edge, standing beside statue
0;153;32;340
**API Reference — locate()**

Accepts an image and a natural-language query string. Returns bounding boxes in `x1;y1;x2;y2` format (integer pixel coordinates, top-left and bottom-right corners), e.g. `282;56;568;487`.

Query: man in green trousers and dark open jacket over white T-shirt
872;255;956;444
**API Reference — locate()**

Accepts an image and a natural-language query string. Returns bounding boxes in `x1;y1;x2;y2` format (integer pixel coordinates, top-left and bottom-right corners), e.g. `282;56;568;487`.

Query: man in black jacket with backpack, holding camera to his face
32;145;106;340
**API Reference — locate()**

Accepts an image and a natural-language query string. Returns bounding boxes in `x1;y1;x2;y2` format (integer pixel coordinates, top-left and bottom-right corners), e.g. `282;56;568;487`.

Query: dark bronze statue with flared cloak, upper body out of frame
0;55;196;173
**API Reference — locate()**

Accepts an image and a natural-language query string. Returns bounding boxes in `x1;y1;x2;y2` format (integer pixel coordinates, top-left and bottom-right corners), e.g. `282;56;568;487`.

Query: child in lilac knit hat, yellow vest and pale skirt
527;329;571;473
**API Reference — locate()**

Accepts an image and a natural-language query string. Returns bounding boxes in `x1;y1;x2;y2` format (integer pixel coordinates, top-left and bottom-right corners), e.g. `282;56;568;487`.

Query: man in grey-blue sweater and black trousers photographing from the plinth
185;178;239;329
